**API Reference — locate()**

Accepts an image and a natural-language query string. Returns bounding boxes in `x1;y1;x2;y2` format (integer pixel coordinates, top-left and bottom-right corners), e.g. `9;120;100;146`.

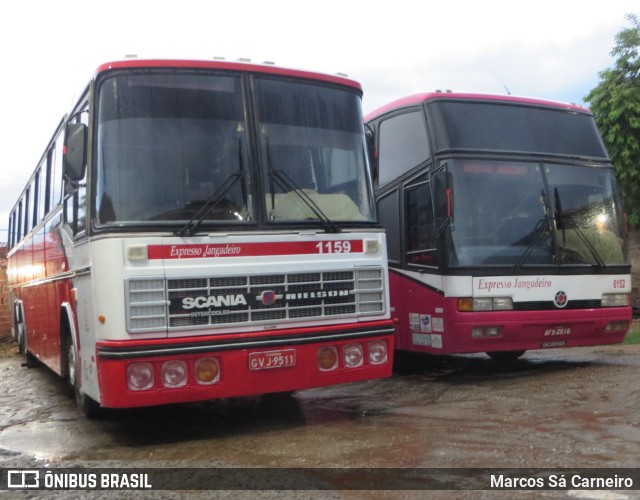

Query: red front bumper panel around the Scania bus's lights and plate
96;330;393;408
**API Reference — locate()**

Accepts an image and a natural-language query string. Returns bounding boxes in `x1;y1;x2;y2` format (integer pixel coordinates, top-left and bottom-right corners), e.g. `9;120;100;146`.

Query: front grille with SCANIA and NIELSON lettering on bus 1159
125;267;386;333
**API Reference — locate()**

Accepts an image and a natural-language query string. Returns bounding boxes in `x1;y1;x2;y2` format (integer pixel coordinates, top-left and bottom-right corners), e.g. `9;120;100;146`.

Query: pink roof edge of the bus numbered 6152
364;92;589;122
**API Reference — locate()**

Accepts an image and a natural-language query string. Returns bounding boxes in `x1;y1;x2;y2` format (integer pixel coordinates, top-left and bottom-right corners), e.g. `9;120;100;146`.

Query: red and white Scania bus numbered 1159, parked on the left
8;60;394;414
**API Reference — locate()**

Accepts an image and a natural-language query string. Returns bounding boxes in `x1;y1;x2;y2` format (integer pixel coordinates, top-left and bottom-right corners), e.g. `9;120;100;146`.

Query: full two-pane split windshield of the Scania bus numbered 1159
93;70;373;230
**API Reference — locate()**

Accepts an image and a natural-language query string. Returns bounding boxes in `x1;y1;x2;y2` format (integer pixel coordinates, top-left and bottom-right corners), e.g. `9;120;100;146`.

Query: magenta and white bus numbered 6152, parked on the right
365;92;631;360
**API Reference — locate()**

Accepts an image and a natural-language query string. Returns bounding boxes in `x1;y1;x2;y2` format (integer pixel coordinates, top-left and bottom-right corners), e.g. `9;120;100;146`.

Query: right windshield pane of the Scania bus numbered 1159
256;78;373;222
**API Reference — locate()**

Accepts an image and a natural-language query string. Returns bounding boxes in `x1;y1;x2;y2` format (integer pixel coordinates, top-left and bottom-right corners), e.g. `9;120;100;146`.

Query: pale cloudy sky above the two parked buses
0;0;640;242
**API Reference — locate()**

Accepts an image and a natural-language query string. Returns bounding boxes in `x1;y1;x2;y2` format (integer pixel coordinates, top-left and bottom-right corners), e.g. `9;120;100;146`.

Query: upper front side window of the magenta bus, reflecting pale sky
378;109;430;186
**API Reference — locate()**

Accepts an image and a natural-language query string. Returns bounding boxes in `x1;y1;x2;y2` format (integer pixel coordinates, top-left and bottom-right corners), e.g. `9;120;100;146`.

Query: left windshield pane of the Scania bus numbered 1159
96;72;252;225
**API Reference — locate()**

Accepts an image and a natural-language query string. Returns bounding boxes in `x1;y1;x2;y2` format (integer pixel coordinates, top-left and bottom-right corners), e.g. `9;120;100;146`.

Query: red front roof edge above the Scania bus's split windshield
95;59;362;92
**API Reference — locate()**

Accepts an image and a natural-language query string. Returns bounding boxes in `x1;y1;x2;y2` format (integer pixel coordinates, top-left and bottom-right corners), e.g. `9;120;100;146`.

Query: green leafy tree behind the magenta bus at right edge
584;14;640;226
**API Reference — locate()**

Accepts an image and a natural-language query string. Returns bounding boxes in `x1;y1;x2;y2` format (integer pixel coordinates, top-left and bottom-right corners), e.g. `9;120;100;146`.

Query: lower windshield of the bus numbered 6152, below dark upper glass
447;160;625;267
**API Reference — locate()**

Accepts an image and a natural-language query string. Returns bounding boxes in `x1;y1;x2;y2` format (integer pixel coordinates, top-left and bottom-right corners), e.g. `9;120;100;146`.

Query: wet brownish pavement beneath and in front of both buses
0;334;640;499
